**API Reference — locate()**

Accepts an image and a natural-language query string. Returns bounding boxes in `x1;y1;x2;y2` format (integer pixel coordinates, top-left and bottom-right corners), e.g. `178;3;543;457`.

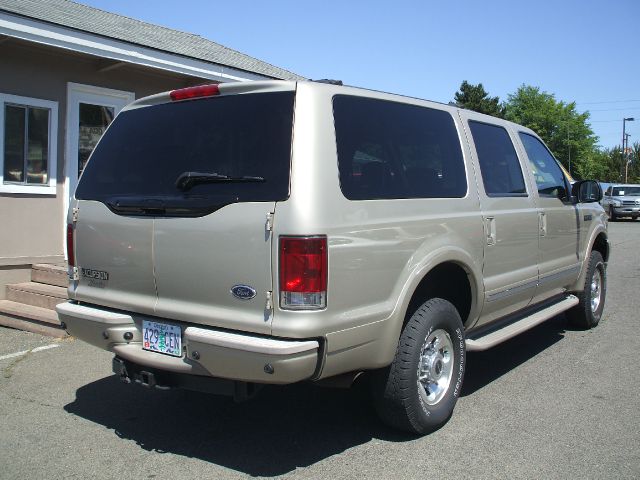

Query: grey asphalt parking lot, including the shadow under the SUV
0;221;640;479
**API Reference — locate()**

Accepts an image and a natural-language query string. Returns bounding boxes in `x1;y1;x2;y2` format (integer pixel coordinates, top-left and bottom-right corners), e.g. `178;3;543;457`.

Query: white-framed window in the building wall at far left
0;93;58;195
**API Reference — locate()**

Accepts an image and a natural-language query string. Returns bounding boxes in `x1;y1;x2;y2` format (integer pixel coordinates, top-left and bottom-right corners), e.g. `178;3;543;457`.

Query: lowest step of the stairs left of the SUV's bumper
0;300;68;338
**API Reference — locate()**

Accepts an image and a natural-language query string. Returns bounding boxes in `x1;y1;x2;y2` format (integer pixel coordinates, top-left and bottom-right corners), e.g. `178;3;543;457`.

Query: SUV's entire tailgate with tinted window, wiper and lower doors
76;83;295;334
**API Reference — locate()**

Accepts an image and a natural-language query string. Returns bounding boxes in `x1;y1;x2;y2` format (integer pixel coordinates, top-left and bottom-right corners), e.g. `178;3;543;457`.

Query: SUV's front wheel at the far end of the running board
567;251;607;329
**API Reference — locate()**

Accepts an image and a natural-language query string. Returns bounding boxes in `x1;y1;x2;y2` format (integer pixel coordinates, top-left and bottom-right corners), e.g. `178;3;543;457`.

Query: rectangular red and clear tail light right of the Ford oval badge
280;236;328;310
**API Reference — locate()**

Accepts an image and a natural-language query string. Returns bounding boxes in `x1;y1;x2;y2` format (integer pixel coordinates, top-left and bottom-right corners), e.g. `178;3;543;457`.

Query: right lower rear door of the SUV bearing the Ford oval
153;202;275;334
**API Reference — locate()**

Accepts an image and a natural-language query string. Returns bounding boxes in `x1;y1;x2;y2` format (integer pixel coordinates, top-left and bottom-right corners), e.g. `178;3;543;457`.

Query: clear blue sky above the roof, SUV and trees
81;0;640;147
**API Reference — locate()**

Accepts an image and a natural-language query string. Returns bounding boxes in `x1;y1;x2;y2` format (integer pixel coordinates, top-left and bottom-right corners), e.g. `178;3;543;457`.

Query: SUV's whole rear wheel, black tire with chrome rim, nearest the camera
372;298;466;434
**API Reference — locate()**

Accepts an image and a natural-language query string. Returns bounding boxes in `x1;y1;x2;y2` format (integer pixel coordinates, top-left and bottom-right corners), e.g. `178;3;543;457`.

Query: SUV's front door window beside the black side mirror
520;132;567;198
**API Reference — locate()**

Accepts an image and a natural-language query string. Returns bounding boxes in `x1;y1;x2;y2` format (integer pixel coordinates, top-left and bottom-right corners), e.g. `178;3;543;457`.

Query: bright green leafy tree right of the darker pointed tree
504;85;604;178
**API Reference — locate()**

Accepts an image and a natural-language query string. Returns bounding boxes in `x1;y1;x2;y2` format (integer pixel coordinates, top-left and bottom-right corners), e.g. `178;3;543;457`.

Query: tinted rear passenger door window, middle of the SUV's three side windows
469;121;527;197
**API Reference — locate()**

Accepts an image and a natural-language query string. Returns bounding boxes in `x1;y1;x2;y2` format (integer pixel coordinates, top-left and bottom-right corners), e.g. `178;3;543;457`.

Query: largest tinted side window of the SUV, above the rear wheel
333;95;467;200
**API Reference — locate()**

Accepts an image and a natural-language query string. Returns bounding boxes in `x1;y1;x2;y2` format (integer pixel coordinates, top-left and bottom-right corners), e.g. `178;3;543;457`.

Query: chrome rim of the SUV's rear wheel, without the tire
418;329;454;405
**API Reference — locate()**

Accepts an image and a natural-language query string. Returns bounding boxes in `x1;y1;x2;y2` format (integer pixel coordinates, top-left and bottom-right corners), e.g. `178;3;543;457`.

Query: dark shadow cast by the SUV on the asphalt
64;316;566;477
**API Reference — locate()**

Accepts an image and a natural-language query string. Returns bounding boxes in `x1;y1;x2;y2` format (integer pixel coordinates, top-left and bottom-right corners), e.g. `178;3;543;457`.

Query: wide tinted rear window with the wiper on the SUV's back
76;92;294;213
